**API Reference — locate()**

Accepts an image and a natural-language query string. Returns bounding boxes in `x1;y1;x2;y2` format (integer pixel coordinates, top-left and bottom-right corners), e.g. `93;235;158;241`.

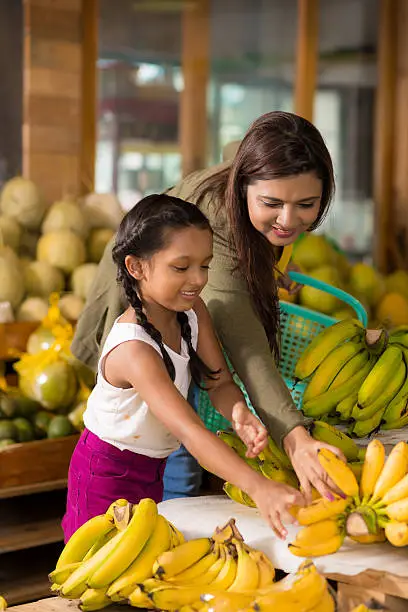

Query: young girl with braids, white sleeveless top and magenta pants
63;195;304;541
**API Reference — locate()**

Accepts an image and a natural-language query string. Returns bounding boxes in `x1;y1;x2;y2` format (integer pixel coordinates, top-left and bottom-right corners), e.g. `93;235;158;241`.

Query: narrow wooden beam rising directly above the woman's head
294;0;319;121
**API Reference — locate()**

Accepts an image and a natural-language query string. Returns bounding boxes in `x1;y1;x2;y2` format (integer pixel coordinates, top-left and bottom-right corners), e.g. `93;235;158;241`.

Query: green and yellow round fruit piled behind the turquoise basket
281;234;408;329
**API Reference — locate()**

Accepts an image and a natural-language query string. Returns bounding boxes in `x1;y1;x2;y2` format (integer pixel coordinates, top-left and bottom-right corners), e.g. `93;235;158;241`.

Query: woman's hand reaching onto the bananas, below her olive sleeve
283;426;346;504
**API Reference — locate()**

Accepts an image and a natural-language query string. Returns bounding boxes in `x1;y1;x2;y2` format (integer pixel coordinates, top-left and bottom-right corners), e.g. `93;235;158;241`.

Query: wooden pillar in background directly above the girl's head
179;0;210;176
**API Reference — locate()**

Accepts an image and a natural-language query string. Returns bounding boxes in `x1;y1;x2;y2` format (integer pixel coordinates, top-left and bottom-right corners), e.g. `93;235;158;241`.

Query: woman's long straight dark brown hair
195;112;334;362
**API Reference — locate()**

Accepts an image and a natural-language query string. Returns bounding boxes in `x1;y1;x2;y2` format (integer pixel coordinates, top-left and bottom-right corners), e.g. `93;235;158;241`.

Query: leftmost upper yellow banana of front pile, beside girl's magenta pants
55;514;114;569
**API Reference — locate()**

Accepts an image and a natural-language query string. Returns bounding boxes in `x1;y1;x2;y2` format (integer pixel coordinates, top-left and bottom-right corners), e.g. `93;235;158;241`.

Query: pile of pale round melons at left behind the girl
0;177;123;321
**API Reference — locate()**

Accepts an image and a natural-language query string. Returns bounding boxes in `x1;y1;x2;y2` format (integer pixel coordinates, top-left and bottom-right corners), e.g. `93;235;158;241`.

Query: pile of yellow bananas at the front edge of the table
49;499;335;612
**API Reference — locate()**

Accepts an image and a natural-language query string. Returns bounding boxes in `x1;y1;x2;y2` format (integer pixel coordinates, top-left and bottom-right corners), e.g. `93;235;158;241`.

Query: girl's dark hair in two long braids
112;194;218;385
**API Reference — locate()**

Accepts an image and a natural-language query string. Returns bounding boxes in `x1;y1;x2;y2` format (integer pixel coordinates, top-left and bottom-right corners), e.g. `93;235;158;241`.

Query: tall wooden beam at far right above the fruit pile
373;0;398;273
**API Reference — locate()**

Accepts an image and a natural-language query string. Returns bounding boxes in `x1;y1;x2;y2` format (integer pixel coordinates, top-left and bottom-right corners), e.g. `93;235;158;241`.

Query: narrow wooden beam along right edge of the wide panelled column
80;0;99;195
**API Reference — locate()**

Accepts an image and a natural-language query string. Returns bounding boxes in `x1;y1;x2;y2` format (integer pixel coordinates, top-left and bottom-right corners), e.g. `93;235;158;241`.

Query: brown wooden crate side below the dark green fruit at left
0;434;79;497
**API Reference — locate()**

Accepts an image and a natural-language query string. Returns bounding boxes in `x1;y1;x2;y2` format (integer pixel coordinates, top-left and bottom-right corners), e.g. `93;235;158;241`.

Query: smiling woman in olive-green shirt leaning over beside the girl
72;112;338;500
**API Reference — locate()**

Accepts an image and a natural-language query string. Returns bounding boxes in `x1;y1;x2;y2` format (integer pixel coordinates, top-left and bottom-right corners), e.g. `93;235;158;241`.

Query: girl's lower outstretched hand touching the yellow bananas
251;478;305;540
